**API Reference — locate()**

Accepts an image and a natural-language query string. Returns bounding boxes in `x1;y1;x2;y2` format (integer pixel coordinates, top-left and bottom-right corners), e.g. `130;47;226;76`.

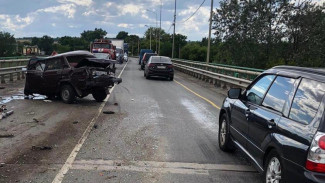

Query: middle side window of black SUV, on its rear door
262;76;295;112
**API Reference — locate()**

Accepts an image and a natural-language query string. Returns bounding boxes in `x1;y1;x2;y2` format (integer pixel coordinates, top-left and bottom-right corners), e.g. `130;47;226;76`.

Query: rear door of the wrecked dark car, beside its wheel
43;57;63;93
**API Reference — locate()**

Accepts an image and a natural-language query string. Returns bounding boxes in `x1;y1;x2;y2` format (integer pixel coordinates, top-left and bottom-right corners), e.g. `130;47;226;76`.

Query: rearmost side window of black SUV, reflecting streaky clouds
289;79;325;124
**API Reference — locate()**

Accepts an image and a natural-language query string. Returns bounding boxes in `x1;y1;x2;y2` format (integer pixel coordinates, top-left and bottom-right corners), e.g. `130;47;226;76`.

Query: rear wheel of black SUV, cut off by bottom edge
264;150;284;183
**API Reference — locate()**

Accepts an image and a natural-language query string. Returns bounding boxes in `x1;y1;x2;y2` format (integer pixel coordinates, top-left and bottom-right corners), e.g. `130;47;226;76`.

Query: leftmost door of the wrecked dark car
26;61;45;93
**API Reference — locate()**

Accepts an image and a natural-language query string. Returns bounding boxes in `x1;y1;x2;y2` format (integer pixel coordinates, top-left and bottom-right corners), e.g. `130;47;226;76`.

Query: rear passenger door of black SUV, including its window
247;76;296;164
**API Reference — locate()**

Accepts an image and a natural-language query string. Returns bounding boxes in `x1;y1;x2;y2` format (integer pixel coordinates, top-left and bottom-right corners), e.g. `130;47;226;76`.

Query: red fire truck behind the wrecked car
90;39;116;60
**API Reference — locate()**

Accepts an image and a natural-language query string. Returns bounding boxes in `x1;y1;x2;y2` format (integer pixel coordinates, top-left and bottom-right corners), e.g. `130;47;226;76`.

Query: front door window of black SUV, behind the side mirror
246;75;275;105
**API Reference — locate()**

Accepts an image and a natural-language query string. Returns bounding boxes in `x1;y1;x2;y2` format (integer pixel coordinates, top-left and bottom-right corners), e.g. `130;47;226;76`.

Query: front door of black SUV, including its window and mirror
230;75;275;149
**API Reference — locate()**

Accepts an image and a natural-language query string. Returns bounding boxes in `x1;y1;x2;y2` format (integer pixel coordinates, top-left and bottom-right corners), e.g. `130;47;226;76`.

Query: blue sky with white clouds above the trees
0;0;219;41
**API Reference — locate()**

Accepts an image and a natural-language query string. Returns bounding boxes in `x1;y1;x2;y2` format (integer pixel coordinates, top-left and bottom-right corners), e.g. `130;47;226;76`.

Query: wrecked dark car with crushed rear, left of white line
24;51;122;103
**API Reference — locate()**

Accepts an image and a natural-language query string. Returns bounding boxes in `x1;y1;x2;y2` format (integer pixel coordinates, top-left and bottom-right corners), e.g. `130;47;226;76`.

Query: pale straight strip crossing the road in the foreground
71;160;256;175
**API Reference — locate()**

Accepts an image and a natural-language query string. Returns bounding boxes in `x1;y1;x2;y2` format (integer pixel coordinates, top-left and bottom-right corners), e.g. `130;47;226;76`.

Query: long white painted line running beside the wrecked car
52;62;129;183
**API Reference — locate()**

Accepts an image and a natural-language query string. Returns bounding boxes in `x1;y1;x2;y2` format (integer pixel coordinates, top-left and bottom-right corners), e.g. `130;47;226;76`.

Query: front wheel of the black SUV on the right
218;114;235;152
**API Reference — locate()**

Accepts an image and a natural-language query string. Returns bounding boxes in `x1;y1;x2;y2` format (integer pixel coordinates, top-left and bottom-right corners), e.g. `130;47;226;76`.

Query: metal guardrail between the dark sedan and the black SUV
172;59;263;88
